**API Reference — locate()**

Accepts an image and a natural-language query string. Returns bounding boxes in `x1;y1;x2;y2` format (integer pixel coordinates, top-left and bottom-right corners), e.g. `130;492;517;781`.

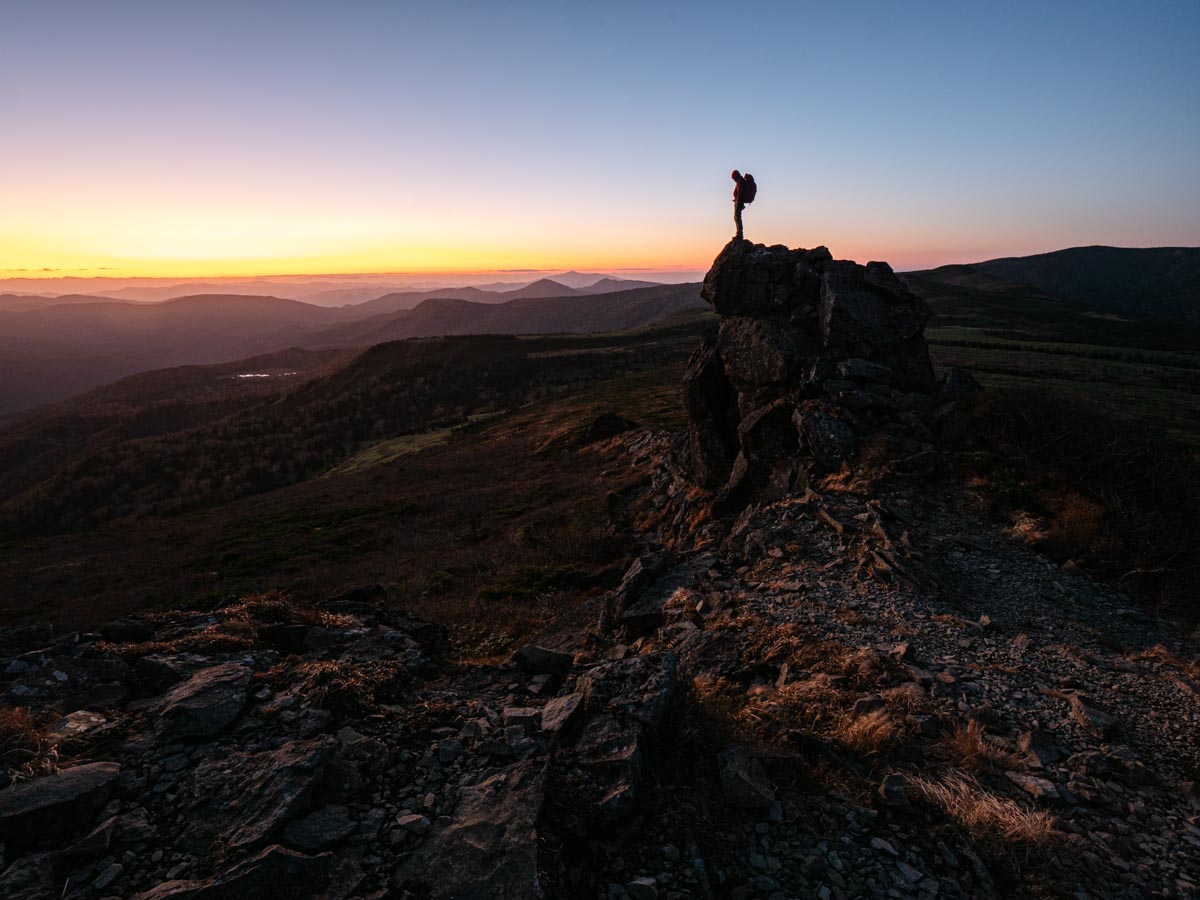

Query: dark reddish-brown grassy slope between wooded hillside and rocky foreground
0;316;707;655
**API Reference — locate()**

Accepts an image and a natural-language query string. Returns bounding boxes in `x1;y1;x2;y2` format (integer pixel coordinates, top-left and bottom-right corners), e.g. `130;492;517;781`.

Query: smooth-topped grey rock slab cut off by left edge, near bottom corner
0;762;121;847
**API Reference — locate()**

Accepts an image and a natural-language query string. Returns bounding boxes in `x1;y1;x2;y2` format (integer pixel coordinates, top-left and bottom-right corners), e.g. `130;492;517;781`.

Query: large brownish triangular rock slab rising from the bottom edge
392;762;546;900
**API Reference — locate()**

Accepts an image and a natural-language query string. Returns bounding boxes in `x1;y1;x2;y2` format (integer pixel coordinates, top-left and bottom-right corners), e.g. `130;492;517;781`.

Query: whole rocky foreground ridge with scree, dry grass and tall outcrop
0;241;1200;900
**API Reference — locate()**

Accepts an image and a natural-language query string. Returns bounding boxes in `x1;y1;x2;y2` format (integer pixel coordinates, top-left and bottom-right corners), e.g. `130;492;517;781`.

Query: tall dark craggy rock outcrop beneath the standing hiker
684;240;955;511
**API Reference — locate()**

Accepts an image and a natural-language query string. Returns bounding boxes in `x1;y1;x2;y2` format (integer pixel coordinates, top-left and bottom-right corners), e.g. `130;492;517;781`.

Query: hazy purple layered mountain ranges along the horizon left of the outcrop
0;272;703;414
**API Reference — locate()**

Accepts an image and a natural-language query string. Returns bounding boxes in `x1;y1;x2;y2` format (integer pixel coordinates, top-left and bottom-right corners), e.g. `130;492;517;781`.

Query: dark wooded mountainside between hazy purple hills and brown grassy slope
0;320;696;535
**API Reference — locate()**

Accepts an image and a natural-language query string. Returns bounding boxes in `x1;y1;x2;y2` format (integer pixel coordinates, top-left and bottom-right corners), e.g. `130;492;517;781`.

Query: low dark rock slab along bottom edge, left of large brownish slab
133;845;330;900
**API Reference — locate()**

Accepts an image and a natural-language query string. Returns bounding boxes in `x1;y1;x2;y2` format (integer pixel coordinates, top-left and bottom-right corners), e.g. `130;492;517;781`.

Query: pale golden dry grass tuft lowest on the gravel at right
908;774;1058;851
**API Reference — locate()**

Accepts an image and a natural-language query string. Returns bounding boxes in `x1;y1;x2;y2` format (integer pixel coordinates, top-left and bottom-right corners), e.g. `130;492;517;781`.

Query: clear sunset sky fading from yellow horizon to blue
0;0;1200;277
